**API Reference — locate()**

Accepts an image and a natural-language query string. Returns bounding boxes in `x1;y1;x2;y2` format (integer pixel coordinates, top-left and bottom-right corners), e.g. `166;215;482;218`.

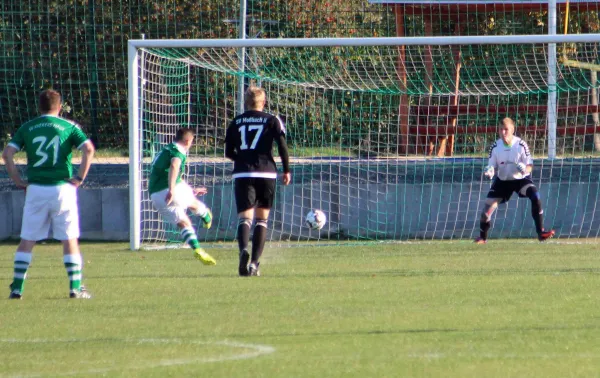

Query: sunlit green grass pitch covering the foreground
0;240;600;377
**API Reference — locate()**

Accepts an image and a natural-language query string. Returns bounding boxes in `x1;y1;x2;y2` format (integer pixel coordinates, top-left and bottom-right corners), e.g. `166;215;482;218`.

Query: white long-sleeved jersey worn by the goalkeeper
488;136;533;181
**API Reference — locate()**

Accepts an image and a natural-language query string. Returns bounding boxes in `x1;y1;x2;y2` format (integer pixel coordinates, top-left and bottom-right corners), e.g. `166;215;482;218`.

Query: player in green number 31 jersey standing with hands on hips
2;89;95;299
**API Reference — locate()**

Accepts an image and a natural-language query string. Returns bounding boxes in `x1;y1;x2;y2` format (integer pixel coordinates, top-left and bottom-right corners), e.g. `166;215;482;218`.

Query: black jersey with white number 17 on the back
225;110;290;179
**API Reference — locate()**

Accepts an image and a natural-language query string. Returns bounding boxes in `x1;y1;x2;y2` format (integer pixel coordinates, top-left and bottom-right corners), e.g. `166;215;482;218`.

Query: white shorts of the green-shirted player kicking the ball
150;181;204;225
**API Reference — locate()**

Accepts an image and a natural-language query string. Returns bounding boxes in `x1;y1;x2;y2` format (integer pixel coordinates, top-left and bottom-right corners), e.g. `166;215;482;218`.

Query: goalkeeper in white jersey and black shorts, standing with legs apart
475;118;554;244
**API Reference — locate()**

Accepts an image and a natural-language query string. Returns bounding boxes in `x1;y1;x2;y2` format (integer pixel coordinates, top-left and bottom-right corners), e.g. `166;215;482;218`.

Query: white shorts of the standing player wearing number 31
21;184;79;241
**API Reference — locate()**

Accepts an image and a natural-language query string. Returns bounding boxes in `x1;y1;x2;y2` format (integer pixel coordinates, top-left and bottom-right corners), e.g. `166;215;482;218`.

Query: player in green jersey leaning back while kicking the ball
148;128;217;265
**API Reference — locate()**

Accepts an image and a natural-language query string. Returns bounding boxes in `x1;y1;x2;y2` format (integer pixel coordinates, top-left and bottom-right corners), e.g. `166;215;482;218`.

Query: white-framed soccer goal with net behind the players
129;34;600;249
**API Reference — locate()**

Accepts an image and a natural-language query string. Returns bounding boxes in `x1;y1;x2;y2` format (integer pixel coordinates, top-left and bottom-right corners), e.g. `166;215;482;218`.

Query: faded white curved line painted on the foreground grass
0;339;275;378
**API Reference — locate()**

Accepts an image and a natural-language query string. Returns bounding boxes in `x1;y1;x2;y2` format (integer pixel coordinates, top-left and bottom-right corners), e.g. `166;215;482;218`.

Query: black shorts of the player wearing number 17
235;177;277;213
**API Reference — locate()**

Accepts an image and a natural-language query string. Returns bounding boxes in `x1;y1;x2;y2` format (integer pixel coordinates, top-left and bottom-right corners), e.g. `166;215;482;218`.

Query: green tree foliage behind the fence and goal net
0;0;600;157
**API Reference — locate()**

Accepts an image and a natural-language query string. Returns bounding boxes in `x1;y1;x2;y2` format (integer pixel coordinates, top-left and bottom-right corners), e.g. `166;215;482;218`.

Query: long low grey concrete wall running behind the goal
0;181;600;241
